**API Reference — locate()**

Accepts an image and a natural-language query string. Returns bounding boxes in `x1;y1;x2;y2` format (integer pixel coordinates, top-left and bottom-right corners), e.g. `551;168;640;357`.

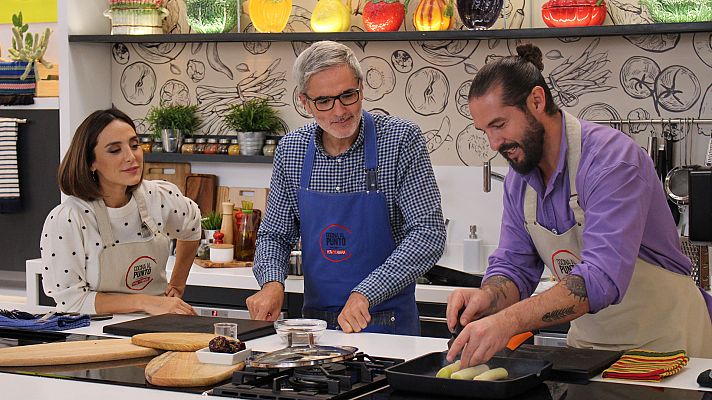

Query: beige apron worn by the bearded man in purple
524;111;712;358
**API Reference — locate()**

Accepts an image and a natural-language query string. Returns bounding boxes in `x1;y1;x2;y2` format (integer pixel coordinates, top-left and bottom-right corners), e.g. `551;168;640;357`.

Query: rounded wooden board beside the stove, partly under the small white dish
146;351;245;387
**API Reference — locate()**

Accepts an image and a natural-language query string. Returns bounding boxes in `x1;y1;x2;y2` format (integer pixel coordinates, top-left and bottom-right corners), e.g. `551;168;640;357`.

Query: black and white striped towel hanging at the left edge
0;118;21;213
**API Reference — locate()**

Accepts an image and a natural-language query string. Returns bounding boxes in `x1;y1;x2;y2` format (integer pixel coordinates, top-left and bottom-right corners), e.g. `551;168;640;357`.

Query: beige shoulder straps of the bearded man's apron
524;110;584;225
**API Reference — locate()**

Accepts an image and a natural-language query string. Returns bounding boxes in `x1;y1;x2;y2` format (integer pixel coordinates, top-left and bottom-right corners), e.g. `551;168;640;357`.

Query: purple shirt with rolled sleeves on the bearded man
485;112;712;314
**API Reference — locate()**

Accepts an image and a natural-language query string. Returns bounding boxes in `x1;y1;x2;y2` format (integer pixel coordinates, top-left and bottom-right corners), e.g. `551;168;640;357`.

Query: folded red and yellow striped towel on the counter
603;349;690;382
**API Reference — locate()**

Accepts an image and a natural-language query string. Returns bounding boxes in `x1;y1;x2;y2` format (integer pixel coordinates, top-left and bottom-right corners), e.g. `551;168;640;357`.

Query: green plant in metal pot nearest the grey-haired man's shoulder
225;99;282;156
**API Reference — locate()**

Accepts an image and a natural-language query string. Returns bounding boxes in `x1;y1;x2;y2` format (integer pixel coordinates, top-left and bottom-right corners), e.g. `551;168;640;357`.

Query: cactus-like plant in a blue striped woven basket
0;12;52;105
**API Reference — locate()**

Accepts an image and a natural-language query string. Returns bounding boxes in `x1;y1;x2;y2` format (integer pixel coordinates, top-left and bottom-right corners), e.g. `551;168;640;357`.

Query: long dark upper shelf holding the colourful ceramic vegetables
69;22;712;43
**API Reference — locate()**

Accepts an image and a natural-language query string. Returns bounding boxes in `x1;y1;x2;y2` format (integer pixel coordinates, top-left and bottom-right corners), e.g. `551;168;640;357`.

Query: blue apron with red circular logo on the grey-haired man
298;111;420;335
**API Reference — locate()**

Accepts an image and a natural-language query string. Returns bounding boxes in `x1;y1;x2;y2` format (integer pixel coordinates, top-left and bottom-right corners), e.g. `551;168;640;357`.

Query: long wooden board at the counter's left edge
0;339;160;366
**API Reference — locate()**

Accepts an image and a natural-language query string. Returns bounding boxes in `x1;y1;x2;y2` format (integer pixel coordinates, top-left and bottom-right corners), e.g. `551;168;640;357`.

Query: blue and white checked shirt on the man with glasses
253;115;445;307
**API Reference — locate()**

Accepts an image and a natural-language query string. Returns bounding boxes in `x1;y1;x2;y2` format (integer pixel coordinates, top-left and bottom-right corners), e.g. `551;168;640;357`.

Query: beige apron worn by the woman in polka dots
92;187;170;295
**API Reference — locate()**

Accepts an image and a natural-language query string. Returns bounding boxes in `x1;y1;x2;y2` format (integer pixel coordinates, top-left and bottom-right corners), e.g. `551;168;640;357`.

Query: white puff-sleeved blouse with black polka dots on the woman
40;180;200;314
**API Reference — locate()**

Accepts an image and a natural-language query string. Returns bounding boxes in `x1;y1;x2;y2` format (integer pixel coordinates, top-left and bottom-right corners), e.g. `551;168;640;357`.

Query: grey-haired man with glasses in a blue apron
247;41;445;335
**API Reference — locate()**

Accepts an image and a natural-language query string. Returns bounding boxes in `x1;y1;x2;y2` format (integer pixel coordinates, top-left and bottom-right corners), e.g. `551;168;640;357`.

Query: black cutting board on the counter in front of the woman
104;314;274;341
